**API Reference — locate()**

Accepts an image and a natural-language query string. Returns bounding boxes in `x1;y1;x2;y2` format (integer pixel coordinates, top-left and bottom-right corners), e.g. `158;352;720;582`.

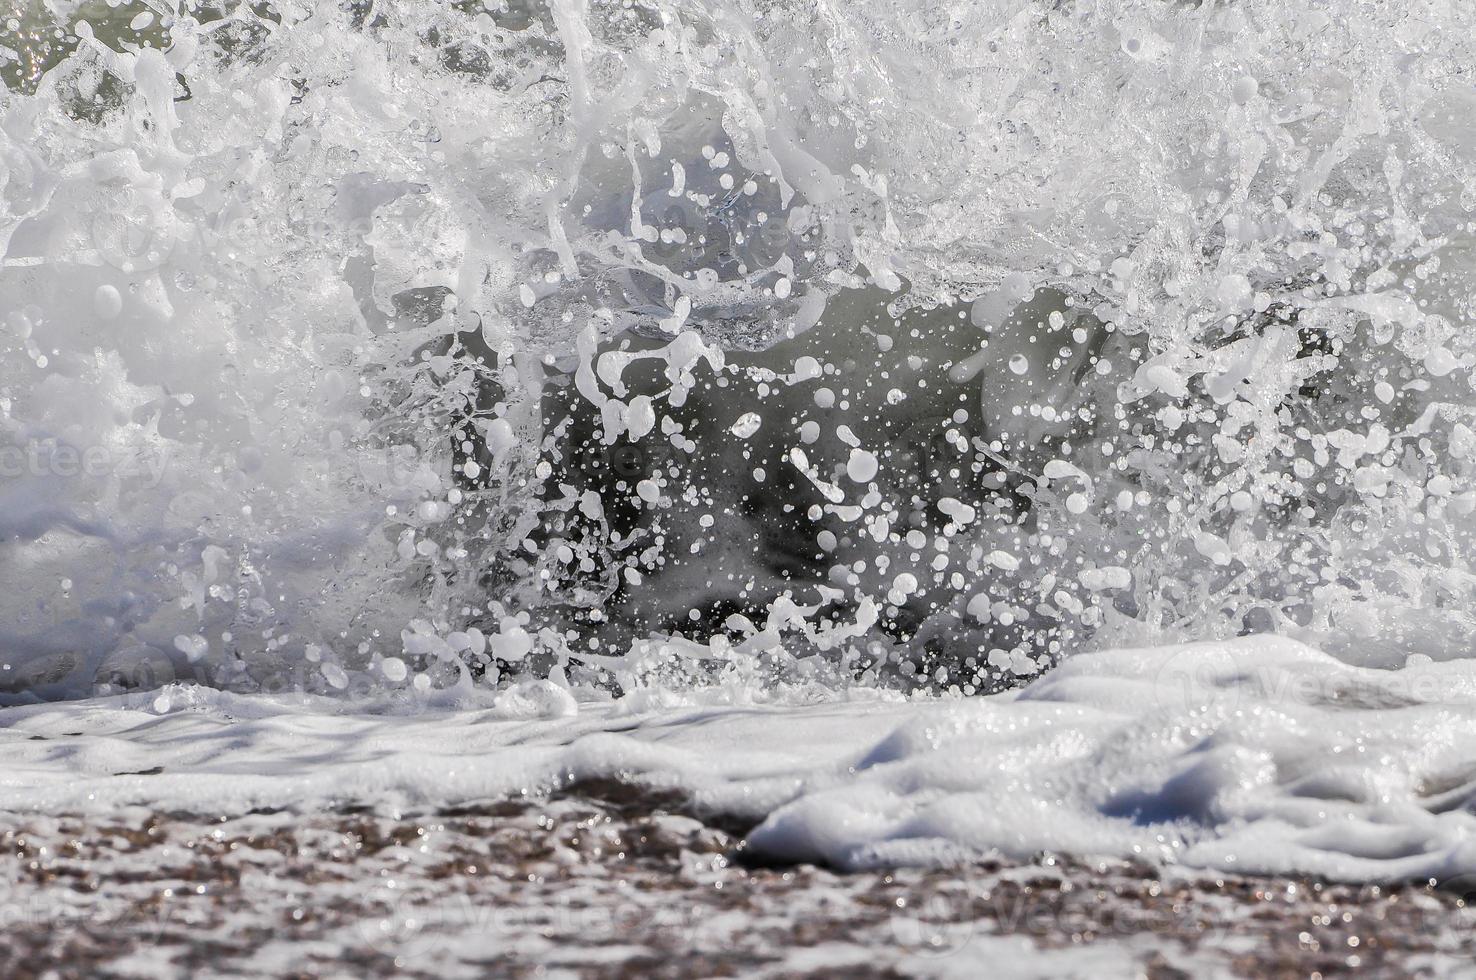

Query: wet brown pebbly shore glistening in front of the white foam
0;782;1476;977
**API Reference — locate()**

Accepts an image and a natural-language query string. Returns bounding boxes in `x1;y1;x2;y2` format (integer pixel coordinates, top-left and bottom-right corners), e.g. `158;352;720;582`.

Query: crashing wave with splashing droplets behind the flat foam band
0;0;1476;698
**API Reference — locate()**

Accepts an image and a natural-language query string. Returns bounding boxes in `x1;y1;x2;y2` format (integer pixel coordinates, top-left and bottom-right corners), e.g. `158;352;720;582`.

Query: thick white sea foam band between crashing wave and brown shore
0;639;1476;883
